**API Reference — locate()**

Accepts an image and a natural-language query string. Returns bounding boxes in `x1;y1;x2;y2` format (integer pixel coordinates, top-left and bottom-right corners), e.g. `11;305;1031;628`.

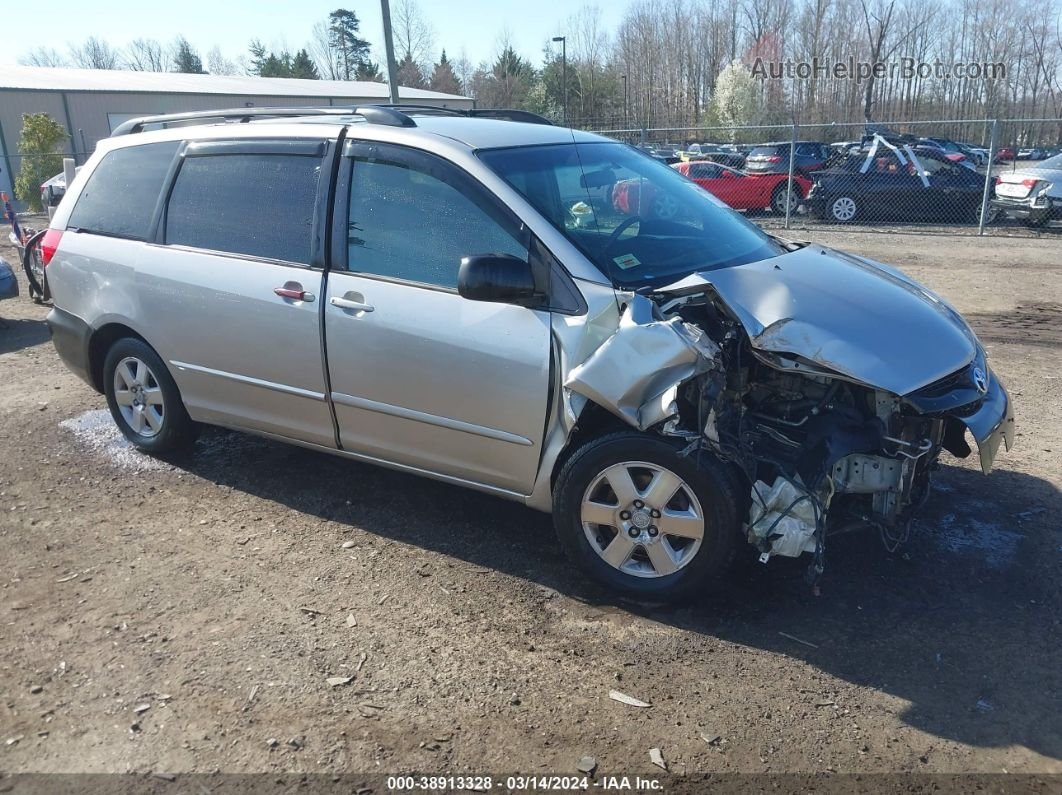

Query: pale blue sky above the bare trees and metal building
0;0;627;66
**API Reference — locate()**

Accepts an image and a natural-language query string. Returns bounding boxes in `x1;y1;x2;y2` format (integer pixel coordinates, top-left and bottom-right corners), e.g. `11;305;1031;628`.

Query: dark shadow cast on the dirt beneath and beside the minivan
163;430;1062;759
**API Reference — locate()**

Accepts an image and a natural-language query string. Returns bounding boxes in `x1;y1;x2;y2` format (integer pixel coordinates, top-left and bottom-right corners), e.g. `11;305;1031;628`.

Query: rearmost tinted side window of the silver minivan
67;141;178;240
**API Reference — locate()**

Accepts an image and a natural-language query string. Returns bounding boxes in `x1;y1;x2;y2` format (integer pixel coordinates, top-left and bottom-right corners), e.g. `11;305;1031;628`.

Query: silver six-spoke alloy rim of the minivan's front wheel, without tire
580;461;704;578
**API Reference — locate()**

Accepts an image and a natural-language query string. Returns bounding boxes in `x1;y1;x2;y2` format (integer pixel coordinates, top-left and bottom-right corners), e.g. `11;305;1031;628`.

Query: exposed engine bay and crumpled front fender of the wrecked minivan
565;260;1013;582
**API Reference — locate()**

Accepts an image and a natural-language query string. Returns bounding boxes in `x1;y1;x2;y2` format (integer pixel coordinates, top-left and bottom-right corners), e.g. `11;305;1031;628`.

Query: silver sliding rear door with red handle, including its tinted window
137;139;336;447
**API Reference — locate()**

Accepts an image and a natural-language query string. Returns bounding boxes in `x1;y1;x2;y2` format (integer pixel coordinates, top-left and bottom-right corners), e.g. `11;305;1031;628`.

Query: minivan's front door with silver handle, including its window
324;142;550;495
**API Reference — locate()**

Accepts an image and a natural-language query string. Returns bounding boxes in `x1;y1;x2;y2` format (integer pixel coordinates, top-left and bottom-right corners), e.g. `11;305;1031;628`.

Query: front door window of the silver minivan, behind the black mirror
348;153;526;289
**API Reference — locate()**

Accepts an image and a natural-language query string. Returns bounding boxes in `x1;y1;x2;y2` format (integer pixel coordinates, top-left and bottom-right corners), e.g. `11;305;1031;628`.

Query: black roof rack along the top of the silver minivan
110;104;552;138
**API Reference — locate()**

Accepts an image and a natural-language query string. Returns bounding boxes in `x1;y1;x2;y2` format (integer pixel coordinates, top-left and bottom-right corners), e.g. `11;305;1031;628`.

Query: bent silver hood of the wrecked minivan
660;245;977;395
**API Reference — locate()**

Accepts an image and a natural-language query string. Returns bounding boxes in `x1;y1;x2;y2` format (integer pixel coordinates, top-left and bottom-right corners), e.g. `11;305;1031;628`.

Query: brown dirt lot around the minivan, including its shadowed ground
0;219;1062;792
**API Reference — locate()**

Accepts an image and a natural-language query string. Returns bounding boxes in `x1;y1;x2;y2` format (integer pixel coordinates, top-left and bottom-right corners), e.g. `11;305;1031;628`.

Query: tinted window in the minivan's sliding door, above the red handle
166;154;321;264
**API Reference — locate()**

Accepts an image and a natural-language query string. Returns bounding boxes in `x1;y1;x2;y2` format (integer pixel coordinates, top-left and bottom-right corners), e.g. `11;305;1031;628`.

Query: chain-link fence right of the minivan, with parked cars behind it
594;119;1062;235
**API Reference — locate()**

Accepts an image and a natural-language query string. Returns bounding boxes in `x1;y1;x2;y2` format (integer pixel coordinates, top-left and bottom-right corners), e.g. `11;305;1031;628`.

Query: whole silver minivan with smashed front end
41;106;1014;600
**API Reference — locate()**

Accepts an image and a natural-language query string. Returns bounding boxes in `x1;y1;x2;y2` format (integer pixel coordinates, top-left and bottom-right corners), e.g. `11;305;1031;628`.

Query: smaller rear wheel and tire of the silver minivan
103;336;196;454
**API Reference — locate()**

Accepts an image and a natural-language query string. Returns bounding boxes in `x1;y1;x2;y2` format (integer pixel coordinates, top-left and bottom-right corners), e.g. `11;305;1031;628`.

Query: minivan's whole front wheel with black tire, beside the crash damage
553;431;738;602
